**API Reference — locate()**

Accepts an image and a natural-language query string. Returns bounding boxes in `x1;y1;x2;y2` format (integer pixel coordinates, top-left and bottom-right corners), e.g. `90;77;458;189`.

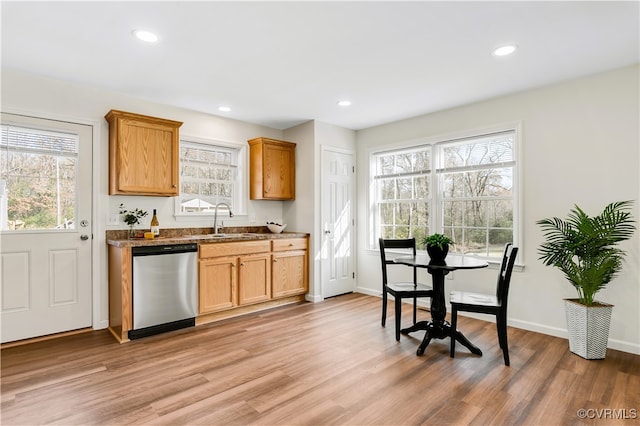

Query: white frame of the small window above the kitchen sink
174;135;248;220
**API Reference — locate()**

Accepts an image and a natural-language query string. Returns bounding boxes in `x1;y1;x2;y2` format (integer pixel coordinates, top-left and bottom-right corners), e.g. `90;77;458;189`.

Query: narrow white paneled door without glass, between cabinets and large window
321;148;355;298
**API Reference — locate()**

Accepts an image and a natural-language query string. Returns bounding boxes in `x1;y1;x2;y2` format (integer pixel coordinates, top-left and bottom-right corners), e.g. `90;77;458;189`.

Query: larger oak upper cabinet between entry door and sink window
105;110;182;197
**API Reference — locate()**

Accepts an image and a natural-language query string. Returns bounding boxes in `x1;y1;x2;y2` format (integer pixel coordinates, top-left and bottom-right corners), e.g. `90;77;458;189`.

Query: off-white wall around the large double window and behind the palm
357;65;640;354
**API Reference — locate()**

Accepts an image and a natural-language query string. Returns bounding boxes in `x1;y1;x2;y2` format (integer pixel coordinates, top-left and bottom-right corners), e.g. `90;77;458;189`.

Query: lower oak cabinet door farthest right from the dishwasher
271;250;307;299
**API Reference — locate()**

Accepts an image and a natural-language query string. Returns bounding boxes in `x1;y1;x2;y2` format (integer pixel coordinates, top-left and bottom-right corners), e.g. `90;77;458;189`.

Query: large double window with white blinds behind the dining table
372;130;518;259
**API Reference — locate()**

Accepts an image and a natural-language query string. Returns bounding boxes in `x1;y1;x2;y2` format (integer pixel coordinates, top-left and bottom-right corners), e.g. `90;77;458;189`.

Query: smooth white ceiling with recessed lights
1;0;640;130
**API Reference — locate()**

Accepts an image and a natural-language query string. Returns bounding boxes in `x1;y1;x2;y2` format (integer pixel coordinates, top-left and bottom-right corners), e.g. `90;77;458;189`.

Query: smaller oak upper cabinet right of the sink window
249;138;296;200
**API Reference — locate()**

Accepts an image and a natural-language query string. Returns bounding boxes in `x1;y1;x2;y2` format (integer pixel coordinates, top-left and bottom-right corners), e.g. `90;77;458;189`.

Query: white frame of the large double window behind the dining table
368;122;523;262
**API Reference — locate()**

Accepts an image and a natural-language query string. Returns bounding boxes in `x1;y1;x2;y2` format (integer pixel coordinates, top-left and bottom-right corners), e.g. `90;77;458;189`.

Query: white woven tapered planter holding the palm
565;299;613;359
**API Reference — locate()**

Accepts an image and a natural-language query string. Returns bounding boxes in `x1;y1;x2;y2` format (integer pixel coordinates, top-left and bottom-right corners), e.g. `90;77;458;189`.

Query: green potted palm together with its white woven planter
536;201;636;359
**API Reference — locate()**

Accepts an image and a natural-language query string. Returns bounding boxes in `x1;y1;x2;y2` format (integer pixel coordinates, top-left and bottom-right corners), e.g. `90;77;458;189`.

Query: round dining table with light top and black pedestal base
393;254;489;355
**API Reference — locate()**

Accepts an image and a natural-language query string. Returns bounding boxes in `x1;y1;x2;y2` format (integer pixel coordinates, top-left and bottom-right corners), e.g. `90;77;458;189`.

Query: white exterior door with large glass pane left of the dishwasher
0;113;93;343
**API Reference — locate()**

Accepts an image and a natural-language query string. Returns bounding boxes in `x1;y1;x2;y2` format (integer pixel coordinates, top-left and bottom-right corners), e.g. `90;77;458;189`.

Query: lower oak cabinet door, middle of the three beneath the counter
238;253;271;305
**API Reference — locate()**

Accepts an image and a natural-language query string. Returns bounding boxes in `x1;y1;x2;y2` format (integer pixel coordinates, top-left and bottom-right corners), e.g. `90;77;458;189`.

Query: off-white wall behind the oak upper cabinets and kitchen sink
1;70;295;328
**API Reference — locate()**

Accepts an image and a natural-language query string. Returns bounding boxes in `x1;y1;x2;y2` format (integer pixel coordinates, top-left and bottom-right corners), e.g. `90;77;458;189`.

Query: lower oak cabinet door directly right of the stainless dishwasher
198;257;238;314
